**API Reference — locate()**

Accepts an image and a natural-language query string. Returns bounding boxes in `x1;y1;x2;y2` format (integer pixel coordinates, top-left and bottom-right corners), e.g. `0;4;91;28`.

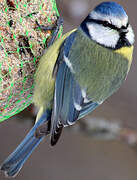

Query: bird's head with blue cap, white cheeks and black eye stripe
80;2;134;49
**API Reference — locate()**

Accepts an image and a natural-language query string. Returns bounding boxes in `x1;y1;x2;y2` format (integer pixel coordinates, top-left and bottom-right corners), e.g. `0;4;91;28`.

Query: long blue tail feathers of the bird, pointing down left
0;110;51;177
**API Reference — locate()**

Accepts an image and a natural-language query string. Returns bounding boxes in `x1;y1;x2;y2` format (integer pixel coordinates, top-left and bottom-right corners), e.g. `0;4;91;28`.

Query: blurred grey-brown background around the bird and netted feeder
0;0;137;180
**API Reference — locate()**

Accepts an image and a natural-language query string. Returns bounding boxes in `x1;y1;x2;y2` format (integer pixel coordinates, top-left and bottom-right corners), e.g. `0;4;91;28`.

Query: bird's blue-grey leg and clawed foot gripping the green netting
36;16;63;47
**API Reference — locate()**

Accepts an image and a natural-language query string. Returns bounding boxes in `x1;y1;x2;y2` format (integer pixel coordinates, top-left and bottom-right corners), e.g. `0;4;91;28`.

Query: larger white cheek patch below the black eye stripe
87;24;119;48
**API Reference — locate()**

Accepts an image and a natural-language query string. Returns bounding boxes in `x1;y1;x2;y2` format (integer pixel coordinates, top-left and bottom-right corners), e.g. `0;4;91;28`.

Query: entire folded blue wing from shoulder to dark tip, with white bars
50;32;98;145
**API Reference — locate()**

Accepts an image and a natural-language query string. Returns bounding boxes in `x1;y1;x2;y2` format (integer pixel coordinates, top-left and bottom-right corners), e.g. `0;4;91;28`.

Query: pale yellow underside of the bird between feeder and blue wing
33;29;76;108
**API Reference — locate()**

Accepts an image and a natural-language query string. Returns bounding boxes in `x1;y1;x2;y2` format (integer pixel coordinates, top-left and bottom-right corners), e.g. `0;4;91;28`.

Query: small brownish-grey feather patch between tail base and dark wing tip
35;121;50;138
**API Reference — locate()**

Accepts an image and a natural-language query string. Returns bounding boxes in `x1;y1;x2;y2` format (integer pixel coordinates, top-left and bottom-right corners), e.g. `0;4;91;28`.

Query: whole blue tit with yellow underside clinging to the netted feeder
0;1;135;177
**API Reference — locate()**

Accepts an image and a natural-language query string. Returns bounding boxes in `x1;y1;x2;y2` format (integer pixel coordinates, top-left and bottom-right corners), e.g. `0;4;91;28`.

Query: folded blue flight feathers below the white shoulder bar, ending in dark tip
51;59;83;145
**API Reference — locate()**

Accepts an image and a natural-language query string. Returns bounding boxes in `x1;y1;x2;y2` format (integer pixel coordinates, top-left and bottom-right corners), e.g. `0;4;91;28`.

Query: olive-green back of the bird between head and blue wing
69;32;128;102
